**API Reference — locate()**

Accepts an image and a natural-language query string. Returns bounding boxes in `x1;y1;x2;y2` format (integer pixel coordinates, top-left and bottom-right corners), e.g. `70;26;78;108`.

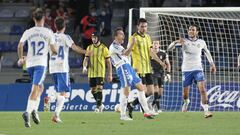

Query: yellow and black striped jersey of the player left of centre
86;43;110;78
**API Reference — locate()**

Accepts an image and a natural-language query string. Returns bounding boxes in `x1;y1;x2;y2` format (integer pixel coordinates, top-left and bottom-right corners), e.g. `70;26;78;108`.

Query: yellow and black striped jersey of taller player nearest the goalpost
129;32;152;75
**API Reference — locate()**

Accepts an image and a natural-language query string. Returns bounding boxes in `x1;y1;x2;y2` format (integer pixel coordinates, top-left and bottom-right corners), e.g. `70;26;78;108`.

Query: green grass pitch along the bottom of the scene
0;112;240;135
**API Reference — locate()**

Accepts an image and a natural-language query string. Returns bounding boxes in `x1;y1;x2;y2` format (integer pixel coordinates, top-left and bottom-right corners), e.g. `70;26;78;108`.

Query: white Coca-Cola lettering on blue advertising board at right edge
207;85;240;108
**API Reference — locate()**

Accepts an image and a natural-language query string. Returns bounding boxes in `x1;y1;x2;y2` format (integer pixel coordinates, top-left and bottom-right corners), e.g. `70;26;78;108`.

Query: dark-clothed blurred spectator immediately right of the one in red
99;0;113;36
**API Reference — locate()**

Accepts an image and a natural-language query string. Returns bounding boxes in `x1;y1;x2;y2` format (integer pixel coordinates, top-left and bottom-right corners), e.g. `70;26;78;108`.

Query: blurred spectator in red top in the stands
81;7;98;49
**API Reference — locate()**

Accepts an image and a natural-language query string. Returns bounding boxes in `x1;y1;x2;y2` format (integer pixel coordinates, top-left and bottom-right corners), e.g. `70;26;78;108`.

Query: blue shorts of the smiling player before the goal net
182;70;205;87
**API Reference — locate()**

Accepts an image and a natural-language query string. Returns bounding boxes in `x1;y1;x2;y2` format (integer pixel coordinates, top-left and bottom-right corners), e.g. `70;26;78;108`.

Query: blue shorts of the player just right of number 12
52;73;71;92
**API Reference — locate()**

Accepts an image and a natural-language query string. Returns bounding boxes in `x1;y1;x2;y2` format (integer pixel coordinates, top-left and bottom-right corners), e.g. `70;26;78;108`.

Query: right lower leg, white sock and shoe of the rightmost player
197;81;212;118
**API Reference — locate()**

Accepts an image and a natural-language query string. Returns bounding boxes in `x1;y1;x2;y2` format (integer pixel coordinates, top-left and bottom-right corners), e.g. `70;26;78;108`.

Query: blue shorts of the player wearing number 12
27;66;46;85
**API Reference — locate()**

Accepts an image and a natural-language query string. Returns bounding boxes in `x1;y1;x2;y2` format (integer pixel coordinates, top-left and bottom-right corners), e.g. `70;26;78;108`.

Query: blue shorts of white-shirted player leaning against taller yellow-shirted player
117;64;141;88
